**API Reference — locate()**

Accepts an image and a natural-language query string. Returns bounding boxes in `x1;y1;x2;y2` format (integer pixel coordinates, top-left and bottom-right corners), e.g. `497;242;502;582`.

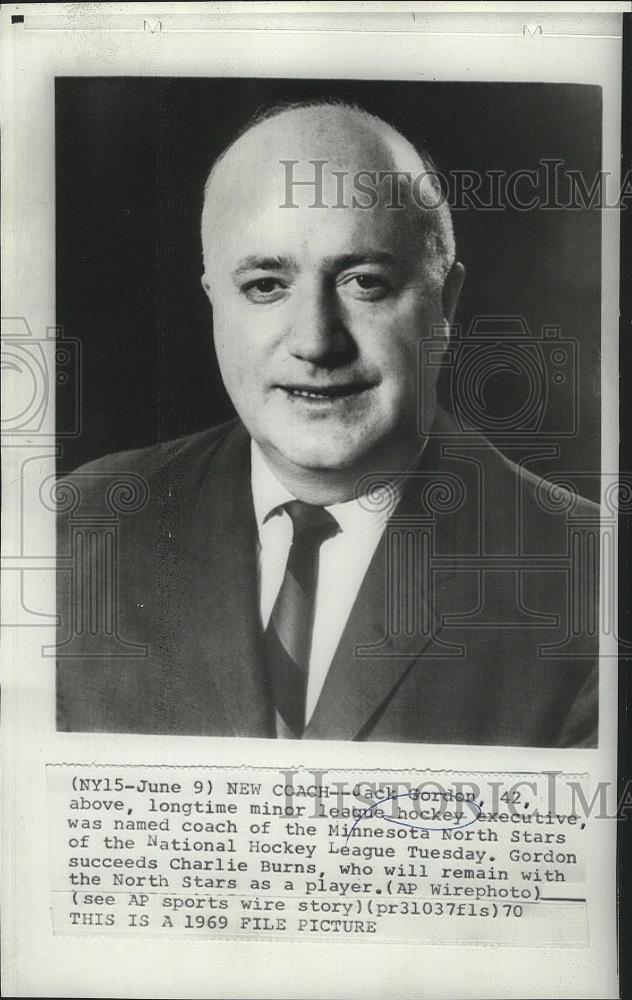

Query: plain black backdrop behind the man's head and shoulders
56;77;601;496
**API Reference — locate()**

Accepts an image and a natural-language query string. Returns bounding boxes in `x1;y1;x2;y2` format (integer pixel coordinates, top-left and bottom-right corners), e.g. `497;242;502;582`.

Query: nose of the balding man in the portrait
287;284;355;368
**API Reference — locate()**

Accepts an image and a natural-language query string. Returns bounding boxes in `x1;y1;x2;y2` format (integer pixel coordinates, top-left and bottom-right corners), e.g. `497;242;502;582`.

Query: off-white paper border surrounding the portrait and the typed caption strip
2;4;625;998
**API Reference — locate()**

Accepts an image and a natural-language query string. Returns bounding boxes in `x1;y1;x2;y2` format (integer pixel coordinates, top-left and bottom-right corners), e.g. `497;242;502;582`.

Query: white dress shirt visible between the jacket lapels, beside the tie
251;441;399;723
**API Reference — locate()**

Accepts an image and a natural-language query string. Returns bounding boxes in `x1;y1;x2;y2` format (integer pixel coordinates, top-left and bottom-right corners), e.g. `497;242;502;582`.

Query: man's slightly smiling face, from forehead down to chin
205;152;450;488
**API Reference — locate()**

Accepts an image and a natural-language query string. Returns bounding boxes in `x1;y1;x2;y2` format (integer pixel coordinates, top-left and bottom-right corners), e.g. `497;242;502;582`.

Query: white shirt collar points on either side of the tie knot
250;441;402;538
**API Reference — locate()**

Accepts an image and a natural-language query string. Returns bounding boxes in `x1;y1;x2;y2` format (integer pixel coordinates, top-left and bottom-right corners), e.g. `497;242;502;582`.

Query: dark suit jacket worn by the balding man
57;415;598;747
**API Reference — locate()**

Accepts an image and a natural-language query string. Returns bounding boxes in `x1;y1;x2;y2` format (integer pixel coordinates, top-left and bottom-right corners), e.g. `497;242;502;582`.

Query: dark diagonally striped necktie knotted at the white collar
265;500;339;736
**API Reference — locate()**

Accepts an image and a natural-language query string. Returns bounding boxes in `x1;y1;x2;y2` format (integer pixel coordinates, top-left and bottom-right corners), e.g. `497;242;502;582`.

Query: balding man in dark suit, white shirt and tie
57;103;598;746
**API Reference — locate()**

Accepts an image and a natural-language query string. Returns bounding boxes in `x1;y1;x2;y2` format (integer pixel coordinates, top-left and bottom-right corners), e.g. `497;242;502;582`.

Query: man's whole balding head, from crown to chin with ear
202;103;462;503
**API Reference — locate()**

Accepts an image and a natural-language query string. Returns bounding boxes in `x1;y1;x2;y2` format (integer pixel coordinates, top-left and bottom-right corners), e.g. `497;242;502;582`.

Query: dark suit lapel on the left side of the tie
183;424;274;736
